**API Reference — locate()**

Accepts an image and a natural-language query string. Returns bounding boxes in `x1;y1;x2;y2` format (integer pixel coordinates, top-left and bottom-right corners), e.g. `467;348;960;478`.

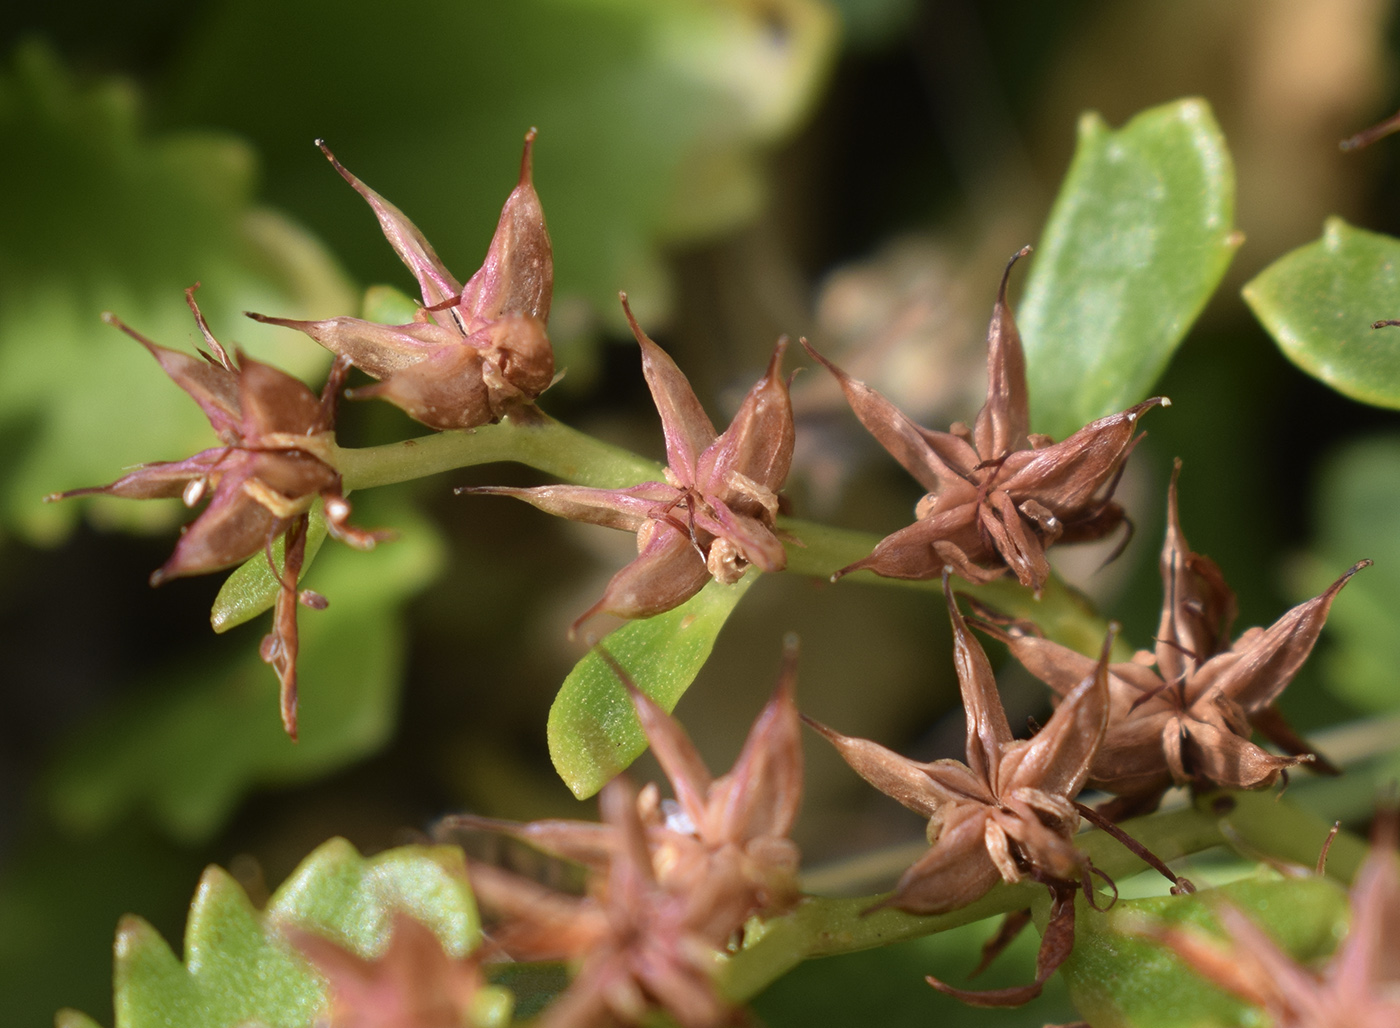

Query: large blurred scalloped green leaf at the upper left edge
0;45;354;541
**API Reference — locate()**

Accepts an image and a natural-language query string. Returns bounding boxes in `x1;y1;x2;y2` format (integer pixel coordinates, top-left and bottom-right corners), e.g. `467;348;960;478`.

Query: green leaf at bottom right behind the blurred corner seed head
1061;878;1348;1028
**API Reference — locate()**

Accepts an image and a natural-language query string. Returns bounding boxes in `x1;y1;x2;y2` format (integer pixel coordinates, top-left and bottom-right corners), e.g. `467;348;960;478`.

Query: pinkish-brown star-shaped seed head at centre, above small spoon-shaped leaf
458;294;794;634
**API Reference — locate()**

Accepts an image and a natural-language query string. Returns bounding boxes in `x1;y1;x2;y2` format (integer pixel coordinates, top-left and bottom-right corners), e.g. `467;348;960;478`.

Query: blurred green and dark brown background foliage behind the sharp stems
0;0;1400;1025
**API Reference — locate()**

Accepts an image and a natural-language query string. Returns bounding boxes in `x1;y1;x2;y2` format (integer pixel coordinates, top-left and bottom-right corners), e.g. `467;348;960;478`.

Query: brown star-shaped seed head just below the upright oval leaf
804;246;1168;592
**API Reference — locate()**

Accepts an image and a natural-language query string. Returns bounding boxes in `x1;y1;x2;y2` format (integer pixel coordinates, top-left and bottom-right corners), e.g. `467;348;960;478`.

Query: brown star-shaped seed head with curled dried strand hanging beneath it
804;570;1113;1006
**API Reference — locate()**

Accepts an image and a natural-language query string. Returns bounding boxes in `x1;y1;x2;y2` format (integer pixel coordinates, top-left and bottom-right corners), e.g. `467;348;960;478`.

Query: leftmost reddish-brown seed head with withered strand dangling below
46;286;388;738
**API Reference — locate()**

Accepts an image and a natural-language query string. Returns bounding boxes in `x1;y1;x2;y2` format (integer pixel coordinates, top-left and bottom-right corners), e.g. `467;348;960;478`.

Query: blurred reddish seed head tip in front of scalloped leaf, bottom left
281;912;498;1028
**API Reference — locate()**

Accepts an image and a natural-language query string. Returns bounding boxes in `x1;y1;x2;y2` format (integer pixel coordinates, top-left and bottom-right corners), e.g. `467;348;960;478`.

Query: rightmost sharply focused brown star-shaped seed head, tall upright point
988;464;1371;819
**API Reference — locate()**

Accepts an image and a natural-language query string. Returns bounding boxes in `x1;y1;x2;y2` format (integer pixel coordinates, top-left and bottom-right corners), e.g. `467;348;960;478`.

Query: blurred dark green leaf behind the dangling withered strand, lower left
49;503;442;842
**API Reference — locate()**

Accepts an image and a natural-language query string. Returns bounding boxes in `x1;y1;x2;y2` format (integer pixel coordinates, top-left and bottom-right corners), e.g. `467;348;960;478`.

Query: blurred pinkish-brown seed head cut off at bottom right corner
1148;811;1400;1028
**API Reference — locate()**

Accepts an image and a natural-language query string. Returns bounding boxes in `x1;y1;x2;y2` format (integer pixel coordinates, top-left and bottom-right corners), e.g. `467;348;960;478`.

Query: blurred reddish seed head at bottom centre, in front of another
472;779;734;1028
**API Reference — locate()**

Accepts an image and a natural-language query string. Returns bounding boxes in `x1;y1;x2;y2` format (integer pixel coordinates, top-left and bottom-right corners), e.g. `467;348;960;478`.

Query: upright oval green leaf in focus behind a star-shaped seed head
1016;99;1240;438
